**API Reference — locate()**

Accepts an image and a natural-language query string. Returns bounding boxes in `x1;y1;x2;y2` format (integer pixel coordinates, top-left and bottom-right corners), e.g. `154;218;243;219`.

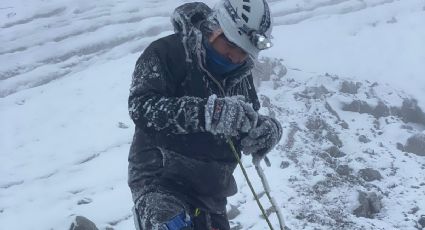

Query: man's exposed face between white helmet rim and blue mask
209;31;248;64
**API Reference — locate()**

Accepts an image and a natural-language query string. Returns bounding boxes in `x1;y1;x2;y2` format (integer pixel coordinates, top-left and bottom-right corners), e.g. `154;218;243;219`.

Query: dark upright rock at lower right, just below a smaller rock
353;192;382;219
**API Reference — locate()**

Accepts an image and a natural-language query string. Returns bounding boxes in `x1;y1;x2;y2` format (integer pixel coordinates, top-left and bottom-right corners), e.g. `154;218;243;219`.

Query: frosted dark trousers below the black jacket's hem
134;192;230;230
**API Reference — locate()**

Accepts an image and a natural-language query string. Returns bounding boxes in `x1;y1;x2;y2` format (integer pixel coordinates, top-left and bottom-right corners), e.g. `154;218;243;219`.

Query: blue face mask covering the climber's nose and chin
203;38;243;76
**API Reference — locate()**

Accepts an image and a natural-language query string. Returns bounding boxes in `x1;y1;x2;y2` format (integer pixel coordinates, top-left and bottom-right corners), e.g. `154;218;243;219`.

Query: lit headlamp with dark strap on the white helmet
224;1;273;50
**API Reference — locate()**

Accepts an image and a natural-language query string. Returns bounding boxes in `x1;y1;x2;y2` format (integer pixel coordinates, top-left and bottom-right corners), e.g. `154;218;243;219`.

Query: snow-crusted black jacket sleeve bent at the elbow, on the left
128;42;206;134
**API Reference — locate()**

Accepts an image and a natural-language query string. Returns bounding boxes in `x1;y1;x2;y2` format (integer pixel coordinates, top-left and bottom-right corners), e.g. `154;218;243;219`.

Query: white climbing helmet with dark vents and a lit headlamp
214;0;273;59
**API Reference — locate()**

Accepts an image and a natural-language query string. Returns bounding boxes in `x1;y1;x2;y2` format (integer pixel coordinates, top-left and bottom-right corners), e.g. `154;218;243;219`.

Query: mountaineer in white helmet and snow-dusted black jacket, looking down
128;0;282;230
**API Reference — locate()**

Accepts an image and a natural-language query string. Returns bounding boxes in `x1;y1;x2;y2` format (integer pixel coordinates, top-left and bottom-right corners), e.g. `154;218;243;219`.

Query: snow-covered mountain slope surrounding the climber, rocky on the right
0;0;425;230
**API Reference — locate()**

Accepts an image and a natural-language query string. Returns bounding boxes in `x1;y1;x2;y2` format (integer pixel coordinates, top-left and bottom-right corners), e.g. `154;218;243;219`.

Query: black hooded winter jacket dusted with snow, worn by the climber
129;3;260;213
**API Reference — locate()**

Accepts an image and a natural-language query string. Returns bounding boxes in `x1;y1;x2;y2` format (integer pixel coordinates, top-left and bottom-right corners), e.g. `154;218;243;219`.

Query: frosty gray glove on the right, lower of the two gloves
241;115;282;160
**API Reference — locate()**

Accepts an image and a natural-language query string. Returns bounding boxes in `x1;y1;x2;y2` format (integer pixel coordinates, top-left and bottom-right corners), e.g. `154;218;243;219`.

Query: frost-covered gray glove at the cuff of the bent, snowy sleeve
205;94;258;136
